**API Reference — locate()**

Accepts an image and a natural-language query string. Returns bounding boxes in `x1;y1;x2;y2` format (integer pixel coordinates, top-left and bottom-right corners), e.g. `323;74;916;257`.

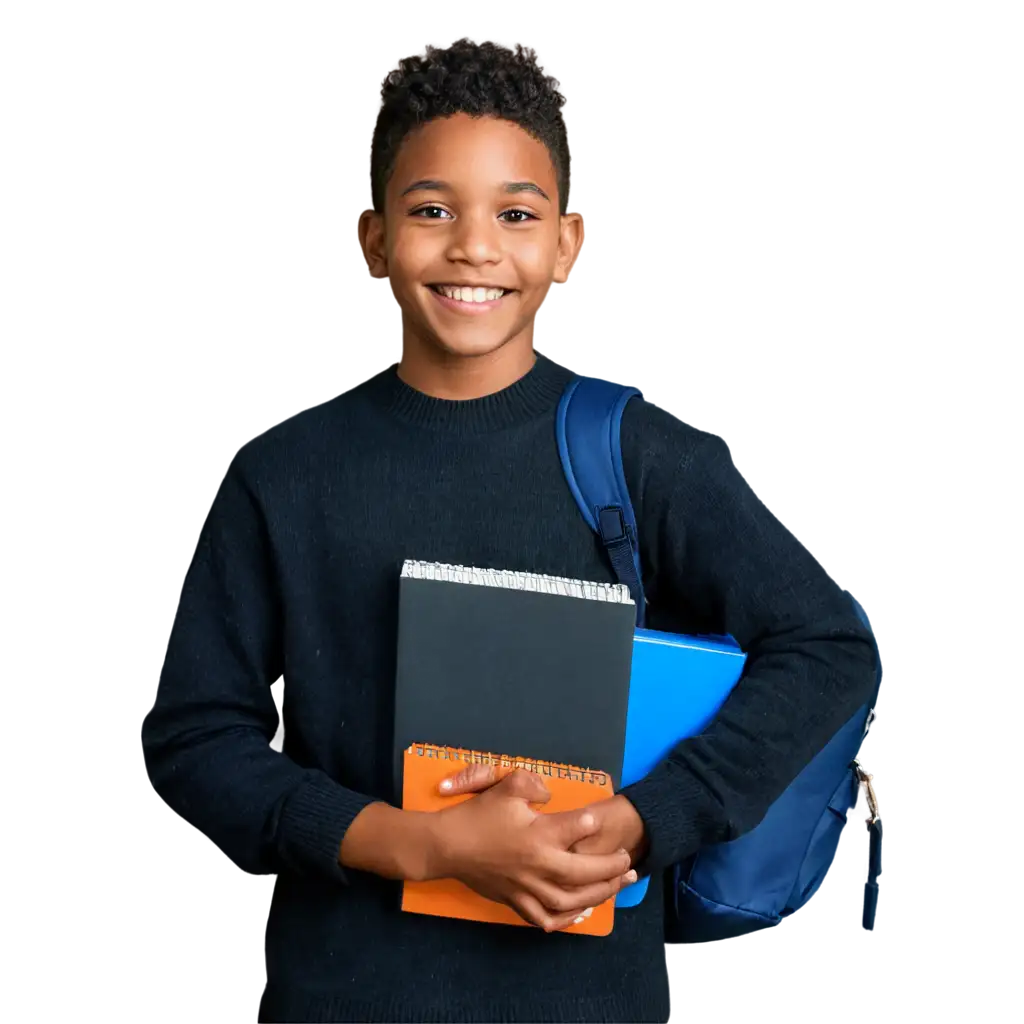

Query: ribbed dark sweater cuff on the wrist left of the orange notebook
278;772;376;884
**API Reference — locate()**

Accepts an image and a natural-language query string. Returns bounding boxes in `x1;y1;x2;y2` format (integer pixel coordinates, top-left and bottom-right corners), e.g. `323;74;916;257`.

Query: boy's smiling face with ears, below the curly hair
357;114;580;356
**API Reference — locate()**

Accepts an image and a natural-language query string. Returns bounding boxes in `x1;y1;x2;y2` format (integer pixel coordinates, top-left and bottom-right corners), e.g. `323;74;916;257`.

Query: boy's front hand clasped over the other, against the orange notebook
430;765;636;932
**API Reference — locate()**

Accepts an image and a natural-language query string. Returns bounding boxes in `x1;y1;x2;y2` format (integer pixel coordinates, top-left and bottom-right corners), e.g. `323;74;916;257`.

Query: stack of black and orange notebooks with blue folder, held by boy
393;561;743;935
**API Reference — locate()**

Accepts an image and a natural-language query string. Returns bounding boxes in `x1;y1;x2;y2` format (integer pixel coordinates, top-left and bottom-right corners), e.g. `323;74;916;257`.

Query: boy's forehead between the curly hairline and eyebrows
391;114;555;194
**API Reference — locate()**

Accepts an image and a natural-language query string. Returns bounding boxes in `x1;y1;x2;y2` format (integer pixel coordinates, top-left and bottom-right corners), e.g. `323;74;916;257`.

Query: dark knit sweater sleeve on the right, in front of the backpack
624;402;876;871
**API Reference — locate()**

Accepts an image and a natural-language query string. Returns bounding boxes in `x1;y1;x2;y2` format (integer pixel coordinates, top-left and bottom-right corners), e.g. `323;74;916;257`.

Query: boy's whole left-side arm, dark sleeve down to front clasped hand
138;454;635;930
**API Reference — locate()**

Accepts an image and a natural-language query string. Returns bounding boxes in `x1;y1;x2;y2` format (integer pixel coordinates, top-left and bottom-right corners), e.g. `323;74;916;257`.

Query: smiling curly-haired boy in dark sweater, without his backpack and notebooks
139;36;874;1021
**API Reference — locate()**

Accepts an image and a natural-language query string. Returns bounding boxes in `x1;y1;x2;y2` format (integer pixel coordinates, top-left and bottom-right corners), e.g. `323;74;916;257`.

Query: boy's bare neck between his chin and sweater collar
397;341;537;401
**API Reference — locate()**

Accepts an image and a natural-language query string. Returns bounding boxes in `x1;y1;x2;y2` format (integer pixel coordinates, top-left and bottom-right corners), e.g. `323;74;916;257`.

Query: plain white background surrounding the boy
0;9;1024;1024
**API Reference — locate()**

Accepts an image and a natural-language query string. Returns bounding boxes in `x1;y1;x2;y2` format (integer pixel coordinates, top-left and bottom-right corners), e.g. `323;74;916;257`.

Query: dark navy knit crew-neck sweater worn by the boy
139;354;874;1021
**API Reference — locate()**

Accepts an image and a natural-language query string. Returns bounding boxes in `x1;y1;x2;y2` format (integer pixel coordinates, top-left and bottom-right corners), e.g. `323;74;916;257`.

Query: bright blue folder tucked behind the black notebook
615;629;746;907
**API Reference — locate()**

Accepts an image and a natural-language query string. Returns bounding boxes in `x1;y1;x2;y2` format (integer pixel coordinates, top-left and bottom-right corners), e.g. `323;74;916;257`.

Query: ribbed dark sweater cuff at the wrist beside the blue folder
621;766;710;874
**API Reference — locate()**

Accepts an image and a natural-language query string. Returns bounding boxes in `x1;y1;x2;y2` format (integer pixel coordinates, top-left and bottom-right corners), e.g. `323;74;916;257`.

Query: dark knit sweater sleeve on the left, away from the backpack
137;461;373;882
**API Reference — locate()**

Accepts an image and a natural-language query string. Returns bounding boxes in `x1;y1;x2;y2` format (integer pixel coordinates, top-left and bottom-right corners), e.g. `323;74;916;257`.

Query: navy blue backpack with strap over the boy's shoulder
556;378;882;940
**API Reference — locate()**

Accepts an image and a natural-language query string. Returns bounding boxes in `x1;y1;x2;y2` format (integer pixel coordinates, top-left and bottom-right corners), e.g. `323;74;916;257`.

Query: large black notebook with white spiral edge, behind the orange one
393;561;636;795
